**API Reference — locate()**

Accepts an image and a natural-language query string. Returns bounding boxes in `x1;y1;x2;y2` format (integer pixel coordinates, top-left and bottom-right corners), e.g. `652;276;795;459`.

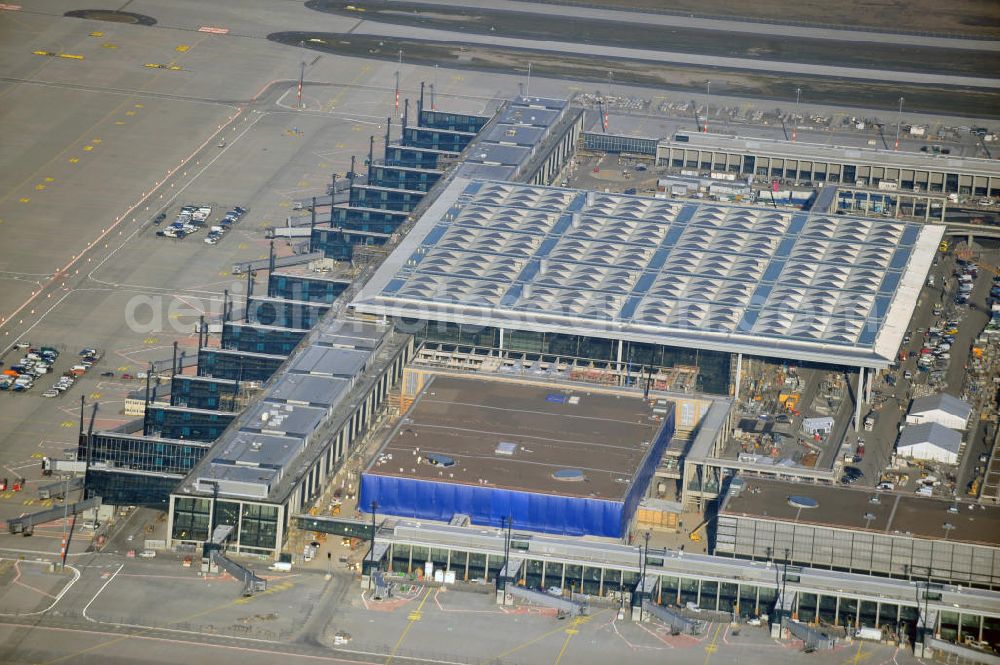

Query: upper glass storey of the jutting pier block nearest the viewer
84;432;209;474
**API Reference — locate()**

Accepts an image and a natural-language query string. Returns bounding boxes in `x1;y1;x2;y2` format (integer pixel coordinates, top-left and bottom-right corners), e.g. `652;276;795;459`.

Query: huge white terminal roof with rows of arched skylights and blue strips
355;177;943;367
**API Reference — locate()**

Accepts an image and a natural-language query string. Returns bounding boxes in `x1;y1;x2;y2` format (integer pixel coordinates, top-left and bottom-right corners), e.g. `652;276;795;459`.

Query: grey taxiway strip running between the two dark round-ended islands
351;21;1000;89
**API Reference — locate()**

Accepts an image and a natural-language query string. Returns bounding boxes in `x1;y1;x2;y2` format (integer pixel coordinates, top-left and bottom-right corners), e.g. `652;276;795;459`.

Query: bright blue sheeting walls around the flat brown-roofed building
358;402;674;538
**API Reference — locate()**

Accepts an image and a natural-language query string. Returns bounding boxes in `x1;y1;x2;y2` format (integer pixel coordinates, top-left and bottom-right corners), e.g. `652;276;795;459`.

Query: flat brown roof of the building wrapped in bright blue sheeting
368;375;672;501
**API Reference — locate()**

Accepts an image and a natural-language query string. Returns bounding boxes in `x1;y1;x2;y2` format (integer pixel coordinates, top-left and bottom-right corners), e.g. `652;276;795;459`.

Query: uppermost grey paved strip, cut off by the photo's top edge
386;0;1000;51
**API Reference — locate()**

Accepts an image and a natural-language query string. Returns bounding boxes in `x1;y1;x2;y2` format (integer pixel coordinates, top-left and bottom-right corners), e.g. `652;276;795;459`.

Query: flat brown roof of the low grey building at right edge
722;478;1000;547
